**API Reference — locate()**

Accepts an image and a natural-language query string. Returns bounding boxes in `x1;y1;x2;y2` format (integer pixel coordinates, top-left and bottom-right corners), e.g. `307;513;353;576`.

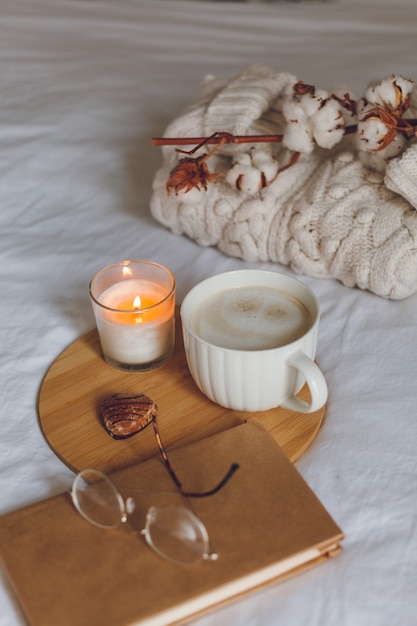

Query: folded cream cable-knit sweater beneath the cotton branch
151;66;417;299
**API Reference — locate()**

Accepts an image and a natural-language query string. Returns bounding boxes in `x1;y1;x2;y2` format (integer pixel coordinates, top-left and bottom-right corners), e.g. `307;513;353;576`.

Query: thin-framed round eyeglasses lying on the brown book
71;417;239;564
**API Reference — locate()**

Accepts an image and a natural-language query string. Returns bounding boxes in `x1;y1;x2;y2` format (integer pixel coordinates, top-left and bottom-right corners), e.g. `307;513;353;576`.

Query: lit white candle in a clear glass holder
89;260;175;372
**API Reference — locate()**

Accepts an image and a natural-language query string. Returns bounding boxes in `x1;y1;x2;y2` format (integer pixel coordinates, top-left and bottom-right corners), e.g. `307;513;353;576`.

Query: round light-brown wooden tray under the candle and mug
38;309;324;472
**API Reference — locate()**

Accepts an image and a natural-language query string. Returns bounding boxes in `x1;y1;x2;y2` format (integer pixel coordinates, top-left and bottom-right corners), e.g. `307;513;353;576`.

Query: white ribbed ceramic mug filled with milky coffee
181;269;327;413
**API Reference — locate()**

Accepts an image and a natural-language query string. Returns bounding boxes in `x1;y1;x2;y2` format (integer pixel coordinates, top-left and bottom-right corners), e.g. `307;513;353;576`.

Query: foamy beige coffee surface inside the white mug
190;286;312;350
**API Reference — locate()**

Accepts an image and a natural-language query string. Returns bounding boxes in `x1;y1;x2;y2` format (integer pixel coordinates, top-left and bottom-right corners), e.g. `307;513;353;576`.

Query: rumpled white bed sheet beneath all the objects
0;0;417;626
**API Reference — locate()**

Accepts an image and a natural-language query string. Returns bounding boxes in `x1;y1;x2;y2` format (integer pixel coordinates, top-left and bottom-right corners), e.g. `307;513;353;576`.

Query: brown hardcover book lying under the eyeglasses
0;420;343;626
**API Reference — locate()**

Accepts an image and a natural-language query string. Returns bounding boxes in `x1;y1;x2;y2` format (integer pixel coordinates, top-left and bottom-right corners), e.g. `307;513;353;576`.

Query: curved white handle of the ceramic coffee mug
281;352;328;413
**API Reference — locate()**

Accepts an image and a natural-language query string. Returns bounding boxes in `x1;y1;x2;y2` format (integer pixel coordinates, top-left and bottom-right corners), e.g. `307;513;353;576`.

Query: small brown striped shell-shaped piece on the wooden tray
101;393;158;439
